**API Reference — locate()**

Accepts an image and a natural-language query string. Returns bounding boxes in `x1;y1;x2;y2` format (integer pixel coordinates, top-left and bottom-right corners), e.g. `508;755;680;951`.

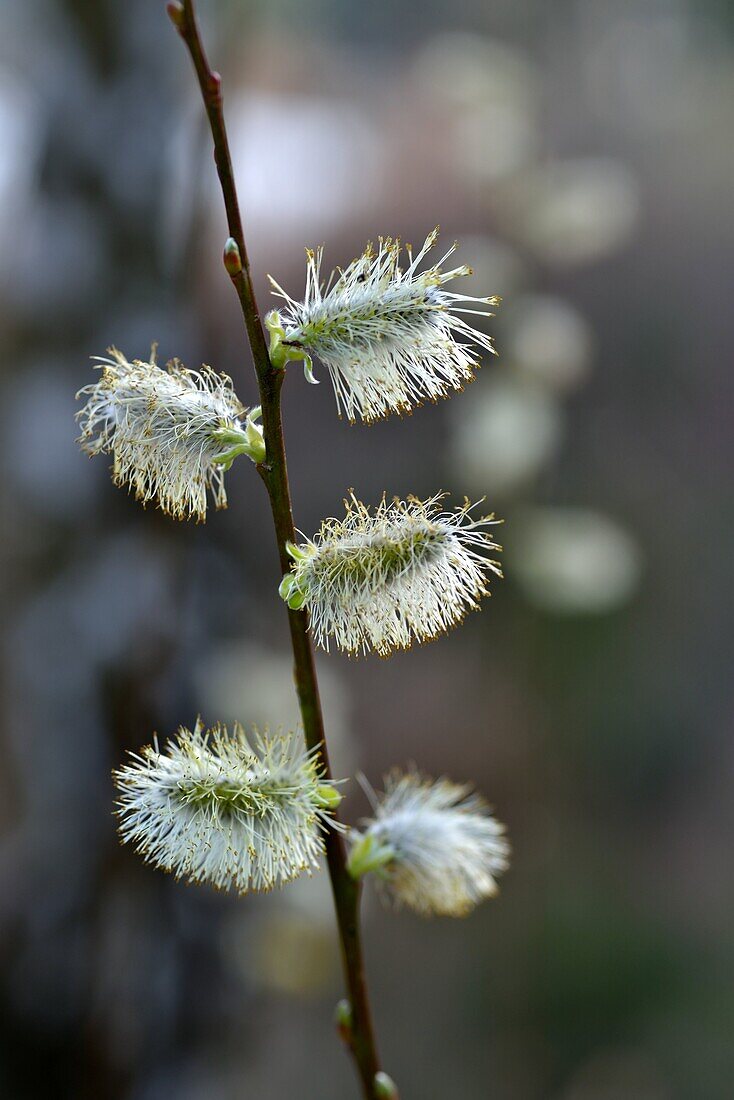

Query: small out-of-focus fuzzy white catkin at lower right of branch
351;771;510;916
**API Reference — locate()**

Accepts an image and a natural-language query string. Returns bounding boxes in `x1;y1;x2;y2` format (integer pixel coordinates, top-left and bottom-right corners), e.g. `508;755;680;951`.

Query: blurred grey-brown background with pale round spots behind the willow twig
0;0;734;1100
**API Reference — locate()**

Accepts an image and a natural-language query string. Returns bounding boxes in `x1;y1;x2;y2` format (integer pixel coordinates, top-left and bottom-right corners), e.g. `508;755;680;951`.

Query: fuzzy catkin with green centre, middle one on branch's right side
281;494;502;657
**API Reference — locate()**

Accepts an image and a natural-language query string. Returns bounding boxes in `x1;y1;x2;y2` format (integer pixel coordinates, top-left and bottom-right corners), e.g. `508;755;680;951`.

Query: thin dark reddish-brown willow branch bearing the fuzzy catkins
167;0;380;1100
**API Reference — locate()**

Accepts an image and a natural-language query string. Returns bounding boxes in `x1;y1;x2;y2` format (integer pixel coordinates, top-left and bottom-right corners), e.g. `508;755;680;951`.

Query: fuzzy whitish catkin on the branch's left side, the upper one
77;348;259;520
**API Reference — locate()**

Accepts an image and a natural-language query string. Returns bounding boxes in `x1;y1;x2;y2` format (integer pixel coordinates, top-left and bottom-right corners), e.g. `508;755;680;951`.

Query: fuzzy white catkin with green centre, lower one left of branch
113;722;330;893
